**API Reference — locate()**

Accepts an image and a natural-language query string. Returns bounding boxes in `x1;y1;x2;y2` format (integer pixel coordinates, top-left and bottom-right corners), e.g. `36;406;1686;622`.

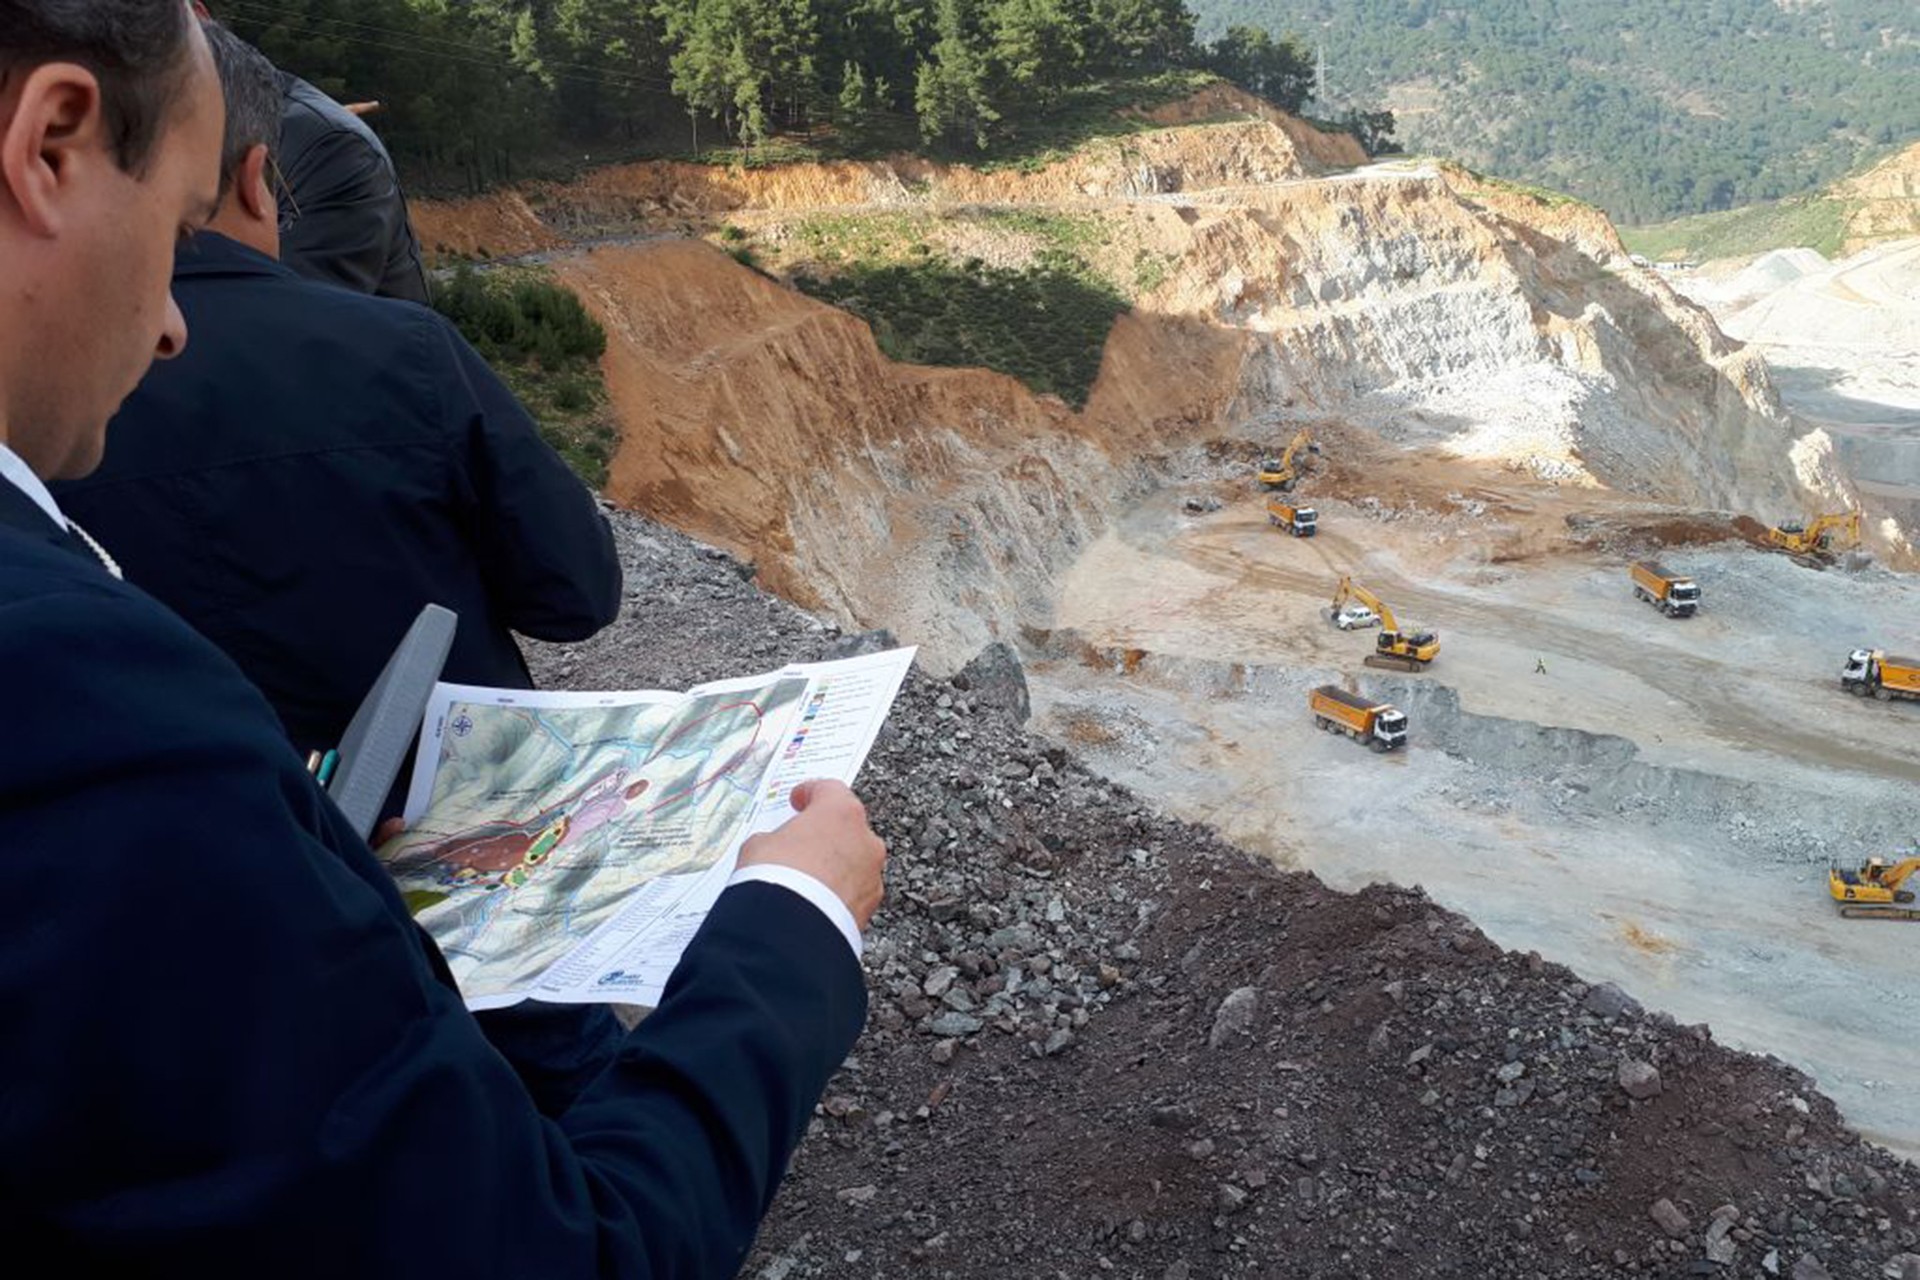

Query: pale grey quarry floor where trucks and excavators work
1033;472;1920;1153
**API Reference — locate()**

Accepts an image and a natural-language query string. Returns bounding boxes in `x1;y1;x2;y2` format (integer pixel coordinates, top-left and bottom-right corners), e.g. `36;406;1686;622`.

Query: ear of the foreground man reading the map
0;61;113;238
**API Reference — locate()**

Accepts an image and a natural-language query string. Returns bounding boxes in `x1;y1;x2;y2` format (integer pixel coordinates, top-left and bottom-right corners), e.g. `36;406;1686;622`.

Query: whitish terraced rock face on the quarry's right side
1171;171;1843;510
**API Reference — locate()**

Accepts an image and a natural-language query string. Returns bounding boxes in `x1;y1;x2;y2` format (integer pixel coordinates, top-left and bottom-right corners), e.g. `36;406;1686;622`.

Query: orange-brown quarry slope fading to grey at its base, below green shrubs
561;240;1240;660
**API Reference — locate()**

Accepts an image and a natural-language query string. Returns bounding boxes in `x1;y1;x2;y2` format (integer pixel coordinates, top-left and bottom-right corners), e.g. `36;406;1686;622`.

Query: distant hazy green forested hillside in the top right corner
1192;0;1920;223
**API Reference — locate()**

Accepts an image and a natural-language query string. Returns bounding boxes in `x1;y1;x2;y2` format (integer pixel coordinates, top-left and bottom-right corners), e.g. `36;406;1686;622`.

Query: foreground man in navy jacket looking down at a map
0;0;885;1276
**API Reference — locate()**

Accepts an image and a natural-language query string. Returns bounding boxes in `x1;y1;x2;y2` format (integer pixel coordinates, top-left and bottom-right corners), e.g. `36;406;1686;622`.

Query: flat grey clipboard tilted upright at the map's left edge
326;604;459;841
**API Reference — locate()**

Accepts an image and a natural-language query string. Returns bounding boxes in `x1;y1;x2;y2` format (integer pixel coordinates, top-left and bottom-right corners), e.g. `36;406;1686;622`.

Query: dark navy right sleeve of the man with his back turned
434;317;620;641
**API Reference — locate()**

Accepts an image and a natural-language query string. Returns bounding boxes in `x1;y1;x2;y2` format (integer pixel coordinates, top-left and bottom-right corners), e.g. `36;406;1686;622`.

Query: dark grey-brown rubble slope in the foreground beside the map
534;514;1920;1280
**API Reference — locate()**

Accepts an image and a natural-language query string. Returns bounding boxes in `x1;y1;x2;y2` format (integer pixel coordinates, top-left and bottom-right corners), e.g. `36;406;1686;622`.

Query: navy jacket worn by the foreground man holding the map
0;583;866;1280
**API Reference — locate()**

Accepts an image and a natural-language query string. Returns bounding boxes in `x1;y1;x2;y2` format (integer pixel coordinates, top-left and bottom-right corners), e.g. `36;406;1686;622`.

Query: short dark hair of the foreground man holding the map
0;0;192;177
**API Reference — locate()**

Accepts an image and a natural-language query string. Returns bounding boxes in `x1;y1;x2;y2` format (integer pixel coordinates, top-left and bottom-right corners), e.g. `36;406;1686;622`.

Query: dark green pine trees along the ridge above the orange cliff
213;0;1336;188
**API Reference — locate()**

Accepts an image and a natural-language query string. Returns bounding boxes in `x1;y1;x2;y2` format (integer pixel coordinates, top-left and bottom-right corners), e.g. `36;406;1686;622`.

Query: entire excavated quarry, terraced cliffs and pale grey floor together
422;104;1920;1157
